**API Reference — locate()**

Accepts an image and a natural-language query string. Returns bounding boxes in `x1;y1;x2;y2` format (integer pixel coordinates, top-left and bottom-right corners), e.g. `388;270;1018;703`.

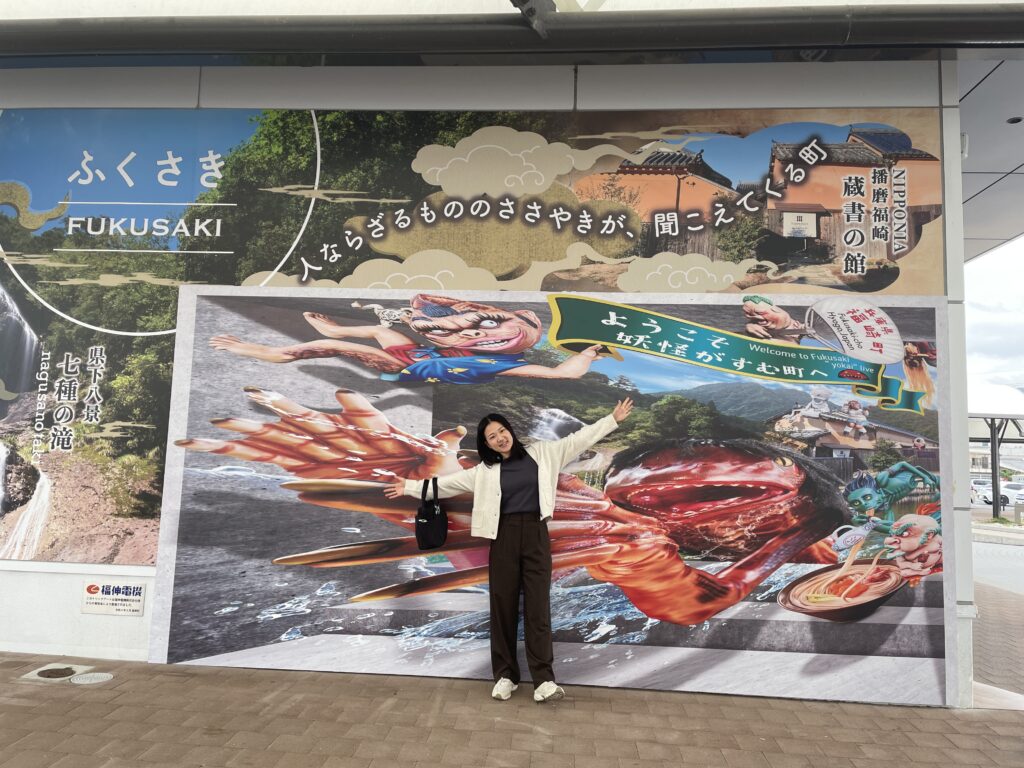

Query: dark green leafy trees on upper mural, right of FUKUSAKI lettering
182;110;570;285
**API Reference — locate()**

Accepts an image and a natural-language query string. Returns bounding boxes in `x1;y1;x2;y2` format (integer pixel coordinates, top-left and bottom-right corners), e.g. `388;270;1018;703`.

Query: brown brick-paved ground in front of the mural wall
0;653;1024;768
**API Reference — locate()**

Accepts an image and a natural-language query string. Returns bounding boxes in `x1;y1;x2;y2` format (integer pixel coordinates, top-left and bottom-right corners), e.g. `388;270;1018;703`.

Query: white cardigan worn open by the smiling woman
406;414;618;539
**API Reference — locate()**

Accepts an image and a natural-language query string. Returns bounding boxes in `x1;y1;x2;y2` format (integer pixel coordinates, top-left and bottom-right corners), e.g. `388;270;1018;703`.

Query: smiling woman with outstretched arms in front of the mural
384;397;633;701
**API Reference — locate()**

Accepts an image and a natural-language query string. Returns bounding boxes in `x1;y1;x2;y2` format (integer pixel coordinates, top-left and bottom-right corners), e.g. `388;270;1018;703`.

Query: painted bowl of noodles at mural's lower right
778;558;906;622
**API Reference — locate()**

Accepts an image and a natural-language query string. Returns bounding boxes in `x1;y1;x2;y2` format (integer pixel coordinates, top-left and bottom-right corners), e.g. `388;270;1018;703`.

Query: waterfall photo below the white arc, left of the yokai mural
0;274;161;564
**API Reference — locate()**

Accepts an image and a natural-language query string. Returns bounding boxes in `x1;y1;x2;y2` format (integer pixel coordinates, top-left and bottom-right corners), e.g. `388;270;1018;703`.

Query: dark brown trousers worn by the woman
487;512;555;688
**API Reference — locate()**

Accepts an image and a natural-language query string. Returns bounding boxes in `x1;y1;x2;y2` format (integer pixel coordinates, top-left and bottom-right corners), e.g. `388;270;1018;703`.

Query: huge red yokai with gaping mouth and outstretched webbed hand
177;389;849;625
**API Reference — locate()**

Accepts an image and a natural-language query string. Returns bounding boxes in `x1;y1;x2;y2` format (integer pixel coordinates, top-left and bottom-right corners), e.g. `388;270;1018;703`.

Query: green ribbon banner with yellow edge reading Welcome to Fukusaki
548;294;924;414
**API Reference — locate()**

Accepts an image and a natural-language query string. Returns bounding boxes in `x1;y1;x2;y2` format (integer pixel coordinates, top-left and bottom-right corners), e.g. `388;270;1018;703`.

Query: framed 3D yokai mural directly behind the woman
153;288;945;705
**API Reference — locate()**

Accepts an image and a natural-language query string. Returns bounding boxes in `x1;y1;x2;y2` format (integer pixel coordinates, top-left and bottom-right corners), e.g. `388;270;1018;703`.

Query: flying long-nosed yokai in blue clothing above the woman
210;294;601;384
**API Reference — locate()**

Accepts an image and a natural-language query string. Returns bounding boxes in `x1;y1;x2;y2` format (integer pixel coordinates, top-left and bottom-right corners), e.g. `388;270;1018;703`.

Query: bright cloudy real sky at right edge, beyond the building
965;238;1024;414
